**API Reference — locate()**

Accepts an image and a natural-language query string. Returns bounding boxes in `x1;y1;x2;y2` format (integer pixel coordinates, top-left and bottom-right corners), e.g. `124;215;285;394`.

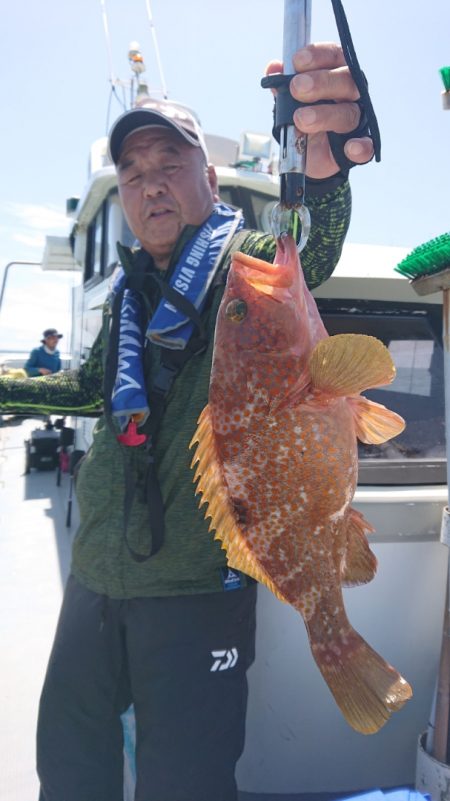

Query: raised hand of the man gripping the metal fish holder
266;42;373;178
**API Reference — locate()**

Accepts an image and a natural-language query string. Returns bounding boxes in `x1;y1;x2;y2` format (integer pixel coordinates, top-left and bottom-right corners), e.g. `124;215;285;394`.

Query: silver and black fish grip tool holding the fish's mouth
261;0;311;251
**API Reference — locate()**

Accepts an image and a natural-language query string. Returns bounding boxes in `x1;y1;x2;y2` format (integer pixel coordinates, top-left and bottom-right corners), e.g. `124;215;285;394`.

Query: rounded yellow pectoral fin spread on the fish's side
309;334;395;397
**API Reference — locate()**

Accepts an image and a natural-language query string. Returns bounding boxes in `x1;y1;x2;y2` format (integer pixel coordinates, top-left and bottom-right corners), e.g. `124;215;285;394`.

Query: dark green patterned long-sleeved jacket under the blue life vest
0;182;351;598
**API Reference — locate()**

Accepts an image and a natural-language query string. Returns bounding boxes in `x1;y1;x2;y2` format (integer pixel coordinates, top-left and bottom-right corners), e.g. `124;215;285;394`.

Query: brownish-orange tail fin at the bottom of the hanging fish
311;625;412;734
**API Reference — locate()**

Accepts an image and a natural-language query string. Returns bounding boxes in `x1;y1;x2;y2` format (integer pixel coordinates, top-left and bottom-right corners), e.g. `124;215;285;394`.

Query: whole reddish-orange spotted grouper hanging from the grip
191;231;412;734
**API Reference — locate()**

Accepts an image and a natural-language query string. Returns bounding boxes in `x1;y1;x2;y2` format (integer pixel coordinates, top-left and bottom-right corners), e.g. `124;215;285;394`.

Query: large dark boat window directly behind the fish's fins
317;299;446;484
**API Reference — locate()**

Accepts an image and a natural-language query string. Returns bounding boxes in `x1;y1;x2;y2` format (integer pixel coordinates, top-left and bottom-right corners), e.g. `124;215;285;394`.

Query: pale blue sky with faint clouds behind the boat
0;0;450;347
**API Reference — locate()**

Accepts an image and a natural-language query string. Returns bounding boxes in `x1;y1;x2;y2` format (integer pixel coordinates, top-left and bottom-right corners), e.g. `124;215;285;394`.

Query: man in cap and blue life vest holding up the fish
0;44;373;801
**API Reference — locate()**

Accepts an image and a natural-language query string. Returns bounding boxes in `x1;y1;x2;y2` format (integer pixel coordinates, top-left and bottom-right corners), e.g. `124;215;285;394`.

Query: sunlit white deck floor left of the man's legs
0;418;77;801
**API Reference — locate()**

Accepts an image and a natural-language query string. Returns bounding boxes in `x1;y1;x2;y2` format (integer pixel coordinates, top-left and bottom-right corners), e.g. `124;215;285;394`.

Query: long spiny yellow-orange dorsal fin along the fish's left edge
189;406;286;601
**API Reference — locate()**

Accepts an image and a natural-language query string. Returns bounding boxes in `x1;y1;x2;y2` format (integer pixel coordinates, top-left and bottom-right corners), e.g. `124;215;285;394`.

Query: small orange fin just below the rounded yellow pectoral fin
348;395;405;445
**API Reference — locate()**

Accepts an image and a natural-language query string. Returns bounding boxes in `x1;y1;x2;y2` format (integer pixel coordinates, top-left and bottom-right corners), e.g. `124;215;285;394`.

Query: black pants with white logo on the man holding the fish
37;577;256;801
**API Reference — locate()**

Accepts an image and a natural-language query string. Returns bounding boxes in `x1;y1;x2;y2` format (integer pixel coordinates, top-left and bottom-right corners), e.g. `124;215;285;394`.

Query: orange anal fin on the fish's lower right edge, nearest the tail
341;508;377;587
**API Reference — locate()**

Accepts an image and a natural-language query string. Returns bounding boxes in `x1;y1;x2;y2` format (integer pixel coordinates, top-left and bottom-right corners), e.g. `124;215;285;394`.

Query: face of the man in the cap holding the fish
117;127;214;269
